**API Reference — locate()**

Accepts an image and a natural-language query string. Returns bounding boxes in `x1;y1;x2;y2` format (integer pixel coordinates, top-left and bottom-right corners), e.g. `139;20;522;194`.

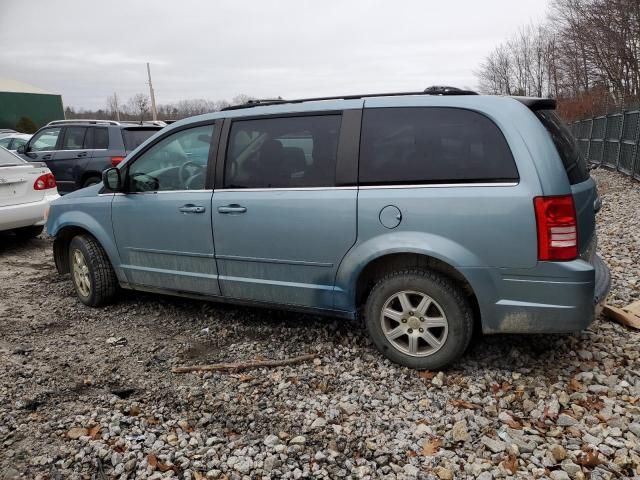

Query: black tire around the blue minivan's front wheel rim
69;235;118;307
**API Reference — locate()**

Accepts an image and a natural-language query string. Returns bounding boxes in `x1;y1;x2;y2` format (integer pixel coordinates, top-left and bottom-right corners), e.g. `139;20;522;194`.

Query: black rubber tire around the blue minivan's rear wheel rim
364;270;473;370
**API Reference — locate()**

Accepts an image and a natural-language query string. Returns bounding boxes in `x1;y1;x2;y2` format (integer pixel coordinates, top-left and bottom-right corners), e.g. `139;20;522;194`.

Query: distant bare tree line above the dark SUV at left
65;93;255;121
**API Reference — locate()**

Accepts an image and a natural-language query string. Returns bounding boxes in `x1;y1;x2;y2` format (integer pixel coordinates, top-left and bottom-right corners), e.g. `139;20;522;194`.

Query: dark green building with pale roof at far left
0;78;64;129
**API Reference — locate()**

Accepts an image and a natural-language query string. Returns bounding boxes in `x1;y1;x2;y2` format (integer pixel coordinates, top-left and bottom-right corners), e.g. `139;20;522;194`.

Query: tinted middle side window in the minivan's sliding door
224;115;341;188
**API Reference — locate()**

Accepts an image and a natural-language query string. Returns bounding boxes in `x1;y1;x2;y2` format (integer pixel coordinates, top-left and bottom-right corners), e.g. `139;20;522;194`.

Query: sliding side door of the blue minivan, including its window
212;114;357;309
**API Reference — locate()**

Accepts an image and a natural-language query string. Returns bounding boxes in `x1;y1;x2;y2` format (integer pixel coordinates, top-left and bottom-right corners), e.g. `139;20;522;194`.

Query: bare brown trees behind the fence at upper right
476;0;640;117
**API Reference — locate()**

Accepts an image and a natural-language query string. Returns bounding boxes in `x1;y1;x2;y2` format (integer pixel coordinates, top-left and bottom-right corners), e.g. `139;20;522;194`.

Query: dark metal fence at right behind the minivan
570;109;640;180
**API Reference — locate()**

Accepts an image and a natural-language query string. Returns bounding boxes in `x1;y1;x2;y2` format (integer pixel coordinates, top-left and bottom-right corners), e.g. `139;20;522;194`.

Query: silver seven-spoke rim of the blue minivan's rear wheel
380;290;449;357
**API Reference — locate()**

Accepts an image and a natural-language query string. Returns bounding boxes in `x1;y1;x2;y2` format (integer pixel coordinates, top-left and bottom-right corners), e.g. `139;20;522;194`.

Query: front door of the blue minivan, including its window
112;124;220;295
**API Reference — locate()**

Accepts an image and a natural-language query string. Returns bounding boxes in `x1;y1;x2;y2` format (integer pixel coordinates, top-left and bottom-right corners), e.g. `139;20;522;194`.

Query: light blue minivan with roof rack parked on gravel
47;88;610;369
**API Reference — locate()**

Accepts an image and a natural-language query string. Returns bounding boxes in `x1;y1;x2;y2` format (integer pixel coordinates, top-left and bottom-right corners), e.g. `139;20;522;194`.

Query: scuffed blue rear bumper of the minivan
463;255;611;333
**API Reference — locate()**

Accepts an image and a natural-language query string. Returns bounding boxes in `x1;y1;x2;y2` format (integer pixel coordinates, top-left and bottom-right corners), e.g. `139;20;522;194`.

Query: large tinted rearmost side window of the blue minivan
359;107;518;185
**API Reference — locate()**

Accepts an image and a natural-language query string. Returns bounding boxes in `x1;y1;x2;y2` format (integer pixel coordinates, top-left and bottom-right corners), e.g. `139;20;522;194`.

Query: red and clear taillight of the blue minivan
533;195;578;261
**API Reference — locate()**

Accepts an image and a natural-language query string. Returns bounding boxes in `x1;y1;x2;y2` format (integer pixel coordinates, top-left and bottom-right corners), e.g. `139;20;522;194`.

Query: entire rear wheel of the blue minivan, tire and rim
365;270;473;370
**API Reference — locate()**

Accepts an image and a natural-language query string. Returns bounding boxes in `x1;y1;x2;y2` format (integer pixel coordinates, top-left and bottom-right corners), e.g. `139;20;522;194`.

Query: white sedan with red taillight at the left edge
0;147;60;238
